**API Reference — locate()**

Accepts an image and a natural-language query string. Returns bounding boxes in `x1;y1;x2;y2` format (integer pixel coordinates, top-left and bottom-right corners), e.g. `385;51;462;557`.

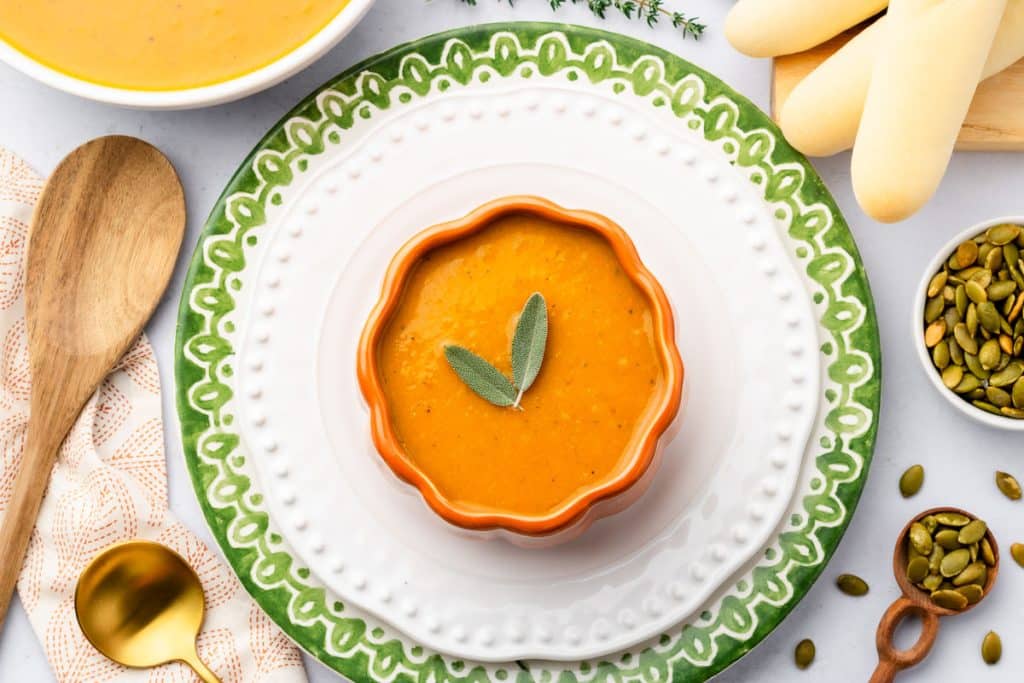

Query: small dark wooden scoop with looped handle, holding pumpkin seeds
870;508;999;683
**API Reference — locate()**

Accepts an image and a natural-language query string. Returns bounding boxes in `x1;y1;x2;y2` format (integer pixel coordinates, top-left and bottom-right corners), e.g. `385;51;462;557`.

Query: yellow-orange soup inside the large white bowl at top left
0;0;348;90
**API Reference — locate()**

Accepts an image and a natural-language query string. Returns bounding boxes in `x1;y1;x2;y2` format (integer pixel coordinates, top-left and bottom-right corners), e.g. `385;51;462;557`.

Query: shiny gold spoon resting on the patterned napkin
75;541;220;683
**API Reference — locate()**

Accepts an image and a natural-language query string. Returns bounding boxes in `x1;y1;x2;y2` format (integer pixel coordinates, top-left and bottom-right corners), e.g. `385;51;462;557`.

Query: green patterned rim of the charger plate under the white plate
176;24;881;682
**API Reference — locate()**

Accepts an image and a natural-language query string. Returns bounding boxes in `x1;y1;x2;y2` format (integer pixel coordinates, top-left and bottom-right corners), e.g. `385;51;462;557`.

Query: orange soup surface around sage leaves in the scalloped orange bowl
378;214;668;517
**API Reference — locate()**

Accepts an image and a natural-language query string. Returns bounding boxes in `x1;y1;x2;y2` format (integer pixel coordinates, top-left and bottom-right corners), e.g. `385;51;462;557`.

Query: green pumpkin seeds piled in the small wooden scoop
906;512;995;610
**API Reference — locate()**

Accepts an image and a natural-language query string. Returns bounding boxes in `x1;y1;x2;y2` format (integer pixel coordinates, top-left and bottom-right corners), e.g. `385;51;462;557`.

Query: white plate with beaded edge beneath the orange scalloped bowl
210;78;821;661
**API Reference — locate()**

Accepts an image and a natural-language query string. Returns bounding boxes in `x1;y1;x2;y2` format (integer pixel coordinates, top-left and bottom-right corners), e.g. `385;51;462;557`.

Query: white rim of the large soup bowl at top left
0;0;374;110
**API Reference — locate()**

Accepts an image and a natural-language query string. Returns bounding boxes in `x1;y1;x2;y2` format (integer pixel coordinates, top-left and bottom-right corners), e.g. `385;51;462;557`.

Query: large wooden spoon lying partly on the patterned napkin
0;135;185;628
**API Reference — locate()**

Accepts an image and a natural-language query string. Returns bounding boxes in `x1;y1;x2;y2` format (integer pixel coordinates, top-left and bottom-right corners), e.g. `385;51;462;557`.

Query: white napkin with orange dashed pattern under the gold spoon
0;147;306;683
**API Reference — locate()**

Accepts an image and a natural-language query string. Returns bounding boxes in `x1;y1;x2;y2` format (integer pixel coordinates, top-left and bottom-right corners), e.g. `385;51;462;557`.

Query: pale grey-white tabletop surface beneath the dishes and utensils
0;0;1024;683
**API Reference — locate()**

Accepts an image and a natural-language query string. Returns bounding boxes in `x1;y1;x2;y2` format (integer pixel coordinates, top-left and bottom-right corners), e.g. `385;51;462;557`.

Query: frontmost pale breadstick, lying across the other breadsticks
851;0;1007;222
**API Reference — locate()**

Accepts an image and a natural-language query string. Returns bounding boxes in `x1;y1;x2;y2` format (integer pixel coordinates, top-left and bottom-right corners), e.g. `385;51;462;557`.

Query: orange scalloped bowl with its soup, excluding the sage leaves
358;197;683;545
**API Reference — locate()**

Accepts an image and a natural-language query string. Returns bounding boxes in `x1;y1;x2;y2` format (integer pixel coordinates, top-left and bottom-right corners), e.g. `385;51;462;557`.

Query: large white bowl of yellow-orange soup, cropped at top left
0;0;374;110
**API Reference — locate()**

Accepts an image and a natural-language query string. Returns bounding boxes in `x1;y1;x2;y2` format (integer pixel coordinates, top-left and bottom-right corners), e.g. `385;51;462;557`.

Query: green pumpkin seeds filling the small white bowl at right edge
924;223;1024;419
